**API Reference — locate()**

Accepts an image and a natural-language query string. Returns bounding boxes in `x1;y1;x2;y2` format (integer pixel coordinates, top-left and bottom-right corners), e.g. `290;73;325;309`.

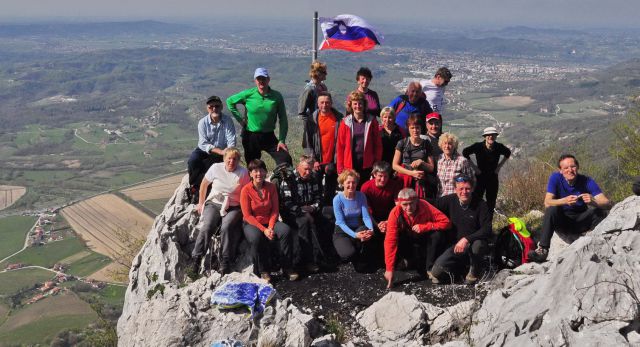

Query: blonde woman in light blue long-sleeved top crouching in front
333;169;382;272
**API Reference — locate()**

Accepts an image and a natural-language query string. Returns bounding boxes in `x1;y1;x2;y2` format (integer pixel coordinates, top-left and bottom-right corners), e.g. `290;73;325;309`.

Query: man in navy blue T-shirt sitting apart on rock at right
528;154;611;262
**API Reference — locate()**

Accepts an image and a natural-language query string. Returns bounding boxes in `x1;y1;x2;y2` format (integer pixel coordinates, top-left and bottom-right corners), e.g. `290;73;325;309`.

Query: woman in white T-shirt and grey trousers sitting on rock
191;147;249;275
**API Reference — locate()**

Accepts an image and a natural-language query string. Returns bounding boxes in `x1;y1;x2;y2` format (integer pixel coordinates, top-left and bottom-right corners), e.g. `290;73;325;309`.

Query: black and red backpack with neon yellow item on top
495;217;534;269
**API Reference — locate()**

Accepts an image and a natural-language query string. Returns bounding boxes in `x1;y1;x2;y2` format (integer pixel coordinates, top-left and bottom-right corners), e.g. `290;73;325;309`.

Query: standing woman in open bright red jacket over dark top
336;91;382;188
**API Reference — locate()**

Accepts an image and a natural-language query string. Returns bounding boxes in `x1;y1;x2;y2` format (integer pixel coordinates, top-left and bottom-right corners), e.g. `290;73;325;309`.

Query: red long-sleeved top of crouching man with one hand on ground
384;199;451;271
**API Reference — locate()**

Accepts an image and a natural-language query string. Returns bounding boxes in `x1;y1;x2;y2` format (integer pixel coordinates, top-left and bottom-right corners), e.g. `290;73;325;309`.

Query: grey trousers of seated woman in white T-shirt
191;202;242;269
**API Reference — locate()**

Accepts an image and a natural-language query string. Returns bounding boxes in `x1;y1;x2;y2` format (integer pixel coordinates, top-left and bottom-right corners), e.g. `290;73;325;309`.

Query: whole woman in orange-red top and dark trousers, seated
240;159;298;281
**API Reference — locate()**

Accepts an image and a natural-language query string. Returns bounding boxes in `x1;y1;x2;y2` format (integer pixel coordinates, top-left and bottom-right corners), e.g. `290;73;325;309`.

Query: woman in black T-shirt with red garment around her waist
393;114;433;199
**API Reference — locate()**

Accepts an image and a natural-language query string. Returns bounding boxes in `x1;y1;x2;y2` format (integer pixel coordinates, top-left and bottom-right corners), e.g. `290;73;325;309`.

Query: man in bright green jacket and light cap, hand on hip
227;67;291;165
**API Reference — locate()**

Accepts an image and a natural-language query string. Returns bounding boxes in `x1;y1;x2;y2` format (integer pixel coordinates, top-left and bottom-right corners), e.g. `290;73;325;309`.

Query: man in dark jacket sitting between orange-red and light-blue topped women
278;155;323;273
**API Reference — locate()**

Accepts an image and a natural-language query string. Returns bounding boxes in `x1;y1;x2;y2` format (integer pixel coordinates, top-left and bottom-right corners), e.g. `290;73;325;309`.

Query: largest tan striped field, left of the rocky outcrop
61;194;153;258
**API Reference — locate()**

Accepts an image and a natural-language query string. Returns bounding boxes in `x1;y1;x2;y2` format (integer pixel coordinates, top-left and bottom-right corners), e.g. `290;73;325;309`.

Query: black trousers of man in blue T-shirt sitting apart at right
539;206;607;248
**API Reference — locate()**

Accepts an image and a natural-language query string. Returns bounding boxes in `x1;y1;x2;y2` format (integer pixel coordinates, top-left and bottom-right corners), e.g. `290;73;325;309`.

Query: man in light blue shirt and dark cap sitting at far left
187;95;236;203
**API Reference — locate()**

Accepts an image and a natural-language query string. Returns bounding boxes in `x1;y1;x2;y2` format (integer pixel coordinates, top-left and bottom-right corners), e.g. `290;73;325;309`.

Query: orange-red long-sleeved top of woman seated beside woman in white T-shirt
240;182;279;231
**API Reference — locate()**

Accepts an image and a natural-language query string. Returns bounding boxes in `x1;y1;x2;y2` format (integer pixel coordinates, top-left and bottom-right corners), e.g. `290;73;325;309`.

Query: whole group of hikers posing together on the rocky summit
182;61;610;287
